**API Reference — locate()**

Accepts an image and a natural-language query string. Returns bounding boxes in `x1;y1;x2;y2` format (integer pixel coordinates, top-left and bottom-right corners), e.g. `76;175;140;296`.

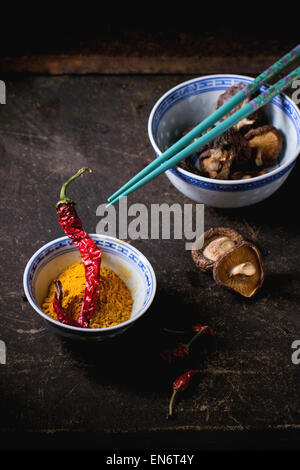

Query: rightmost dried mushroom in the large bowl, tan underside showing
245;126;283;167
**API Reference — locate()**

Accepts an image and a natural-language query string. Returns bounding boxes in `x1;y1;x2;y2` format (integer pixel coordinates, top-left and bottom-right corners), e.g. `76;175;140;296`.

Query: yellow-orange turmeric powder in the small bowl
42;261;133;328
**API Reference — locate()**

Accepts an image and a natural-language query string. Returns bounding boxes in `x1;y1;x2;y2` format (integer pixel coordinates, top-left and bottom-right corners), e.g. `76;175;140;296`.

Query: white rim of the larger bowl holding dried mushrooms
148;73;300;186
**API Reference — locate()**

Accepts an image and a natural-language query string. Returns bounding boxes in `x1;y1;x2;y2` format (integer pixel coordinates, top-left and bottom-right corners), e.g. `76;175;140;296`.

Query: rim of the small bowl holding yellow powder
23;233;157;334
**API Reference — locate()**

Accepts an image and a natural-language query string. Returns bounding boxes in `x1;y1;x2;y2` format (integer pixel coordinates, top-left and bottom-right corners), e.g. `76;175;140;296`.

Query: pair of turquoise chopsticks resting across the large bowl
106;44;300;207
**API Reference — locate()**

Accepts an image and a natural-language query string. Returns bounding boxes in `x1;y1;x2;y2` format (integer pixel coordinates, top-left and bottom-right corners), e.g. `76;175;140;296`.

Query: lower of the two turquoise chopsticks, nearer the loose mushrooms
106;67;300;207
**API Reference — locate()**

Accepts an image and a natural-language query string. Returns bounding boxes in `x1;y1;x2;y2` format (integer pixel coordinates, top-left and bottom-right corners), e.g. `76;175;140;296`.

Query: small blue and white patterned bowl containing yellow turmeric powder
23;234;156;340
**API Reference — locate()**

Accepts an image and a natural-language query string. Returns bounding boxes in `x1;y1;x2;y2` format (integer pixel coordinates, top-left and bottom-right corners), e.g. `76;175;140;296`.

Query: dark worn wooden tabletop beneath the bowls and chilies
0;71;300;449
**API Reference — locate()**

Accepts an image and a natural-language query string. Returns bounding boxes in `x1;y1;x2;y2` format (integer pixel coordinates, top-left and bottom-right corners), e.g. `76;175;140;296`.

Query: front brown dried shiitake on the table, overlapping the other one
213;242;264;297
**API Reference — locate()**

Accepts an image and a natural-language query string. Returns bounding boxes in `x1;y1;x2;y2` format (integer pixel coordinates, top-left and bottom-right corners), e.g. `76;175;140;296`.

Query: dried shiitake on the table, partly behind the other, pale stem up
192;227;244;272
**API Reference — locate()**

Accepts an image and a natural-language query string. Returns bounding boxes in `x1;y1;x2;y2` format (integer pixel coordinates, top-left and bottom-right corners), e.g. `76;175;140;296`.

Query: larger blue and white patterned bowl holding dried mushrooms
148;74;300;208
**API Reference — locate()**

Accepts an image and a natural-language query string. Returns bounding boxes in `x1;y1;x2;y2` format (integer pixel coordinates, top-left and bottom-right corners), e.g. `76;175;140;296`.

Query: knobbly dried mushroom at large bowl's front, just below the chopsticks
199;129;251;180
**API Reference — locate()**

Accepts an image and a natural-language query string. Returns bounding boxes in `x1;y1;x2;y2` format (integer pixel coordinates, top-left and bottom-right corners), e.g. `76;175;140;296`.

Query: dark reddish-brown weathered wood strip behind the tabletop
0;30;298;75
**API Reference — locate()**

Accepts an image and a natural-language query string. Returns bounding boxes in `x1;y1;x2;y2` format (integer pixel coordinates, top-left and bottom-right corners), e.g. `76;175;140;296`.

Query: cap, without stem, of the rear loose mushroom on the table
192;227;244;272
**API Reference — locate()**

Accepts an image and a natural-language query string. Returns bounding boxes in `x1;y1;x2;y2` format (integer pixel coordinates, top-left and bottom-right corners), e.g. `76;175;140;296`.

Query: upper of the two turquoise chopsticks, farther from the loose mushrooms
108;44;300;201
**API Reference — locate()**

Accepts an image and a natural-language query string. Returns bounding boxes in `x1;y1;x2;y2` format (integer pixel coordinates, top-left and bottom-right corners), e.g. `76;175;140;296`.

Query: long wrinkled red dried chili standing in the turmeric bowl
53;167;102;328
